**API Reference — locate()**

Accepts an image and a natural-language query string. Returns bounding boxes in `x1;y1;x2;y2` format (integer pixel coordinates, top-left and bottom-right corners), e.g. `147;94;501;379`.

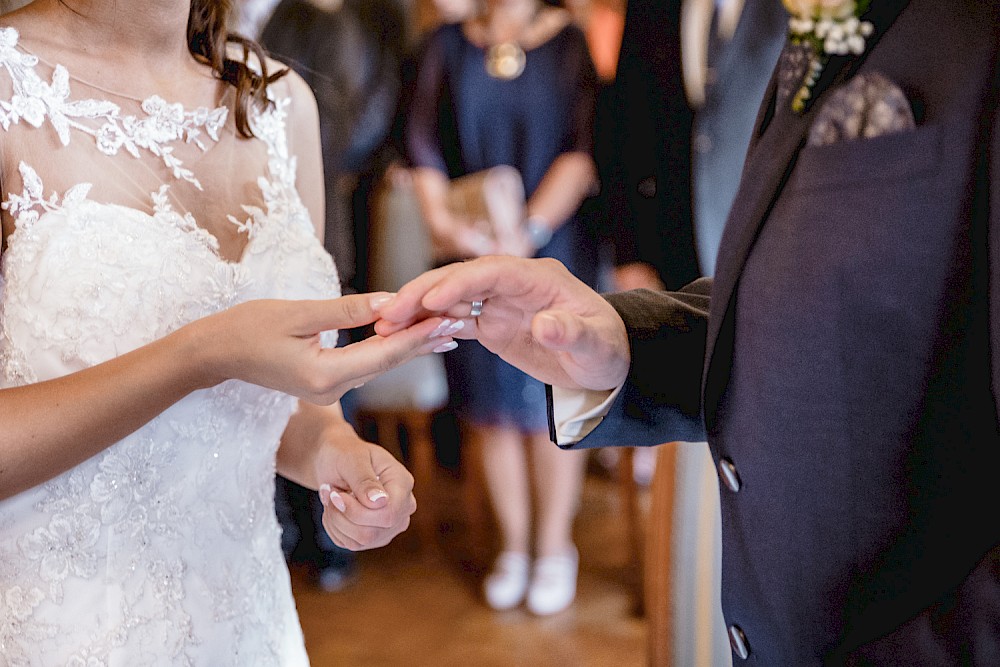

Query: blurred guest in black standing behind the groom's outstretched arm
606;0;787;289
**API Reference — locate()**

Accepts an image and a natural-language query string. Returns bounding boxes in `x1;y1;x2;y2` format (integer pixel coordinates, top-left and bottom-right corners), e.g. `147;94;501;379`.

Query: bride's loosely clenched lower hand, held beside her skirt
316;437;417;551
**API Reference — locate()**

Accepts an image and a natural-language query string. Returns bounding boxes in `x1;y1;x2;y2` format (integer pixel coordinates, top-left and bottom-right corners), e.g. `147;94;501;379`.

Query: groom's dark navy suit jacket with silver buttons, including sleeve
579;0;1000;666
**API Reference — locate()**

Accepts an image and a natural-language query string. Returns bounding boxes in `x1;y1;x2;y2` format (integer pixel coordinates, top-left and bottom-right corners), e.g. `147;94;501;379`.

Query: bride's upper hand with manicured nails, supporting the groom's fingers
191;293;452;405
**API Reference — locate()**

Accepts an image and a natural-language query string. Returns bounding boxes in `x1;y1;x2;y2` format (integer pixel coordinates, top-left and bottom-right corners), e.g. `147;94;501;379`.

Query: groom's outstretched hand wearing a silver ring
375;257;631;390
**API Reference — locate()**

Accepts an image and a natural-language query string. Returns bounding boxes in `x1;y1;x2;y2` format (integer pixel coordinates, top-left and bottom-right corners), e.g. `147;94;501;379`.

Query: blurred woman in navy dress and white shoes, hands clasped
405;0;598;615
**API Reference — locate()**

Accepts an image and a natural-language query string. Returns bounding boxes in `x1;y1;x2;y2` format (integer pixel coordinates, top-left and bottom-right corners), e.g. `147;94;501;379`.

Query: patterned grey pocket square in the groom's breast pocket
809;72;916;146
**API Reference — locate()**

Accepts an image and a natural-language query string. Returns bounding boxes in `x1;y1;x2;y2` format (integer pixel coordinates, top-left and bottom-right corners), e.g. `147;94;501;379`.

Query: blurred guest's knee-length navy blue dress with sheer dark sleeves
405;20;598;431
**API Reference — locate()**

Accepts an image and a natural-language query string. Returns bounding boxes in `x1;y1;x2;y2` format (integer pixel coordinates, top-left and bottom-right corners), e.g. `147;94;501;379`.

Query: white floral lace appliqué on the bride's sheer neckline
0;27;298;266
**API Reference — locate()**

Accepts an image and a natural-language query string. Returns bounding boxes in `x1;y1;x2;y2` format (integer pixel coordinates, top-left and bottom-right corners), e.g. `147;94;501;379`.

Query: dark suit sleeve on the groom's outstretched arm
549;278;712;449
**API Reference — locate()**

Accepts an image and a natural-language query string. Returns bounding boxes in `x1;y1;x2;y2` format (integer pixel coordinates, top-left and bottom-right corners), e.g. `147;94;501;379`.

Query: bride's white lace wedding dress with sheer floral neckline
0;28;339;667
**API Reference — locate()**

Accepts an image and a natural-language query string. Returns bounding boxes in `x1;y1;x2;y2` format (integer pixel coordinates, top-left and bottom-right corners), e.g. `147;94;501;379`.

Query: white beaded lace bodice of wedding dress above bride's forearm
0;200;339;381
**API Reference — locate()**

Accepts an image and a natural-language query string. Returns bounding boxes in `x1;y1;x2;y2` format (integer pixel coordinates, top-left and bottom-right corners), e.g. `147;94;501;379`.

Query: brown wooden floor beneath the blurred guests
293;464;648;667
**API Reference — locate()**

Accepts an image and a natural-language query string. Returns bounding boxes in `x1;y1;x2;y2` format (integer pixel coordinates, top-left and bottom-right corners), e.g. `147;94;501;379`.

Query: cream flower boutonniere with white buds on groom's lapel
782;0;874;113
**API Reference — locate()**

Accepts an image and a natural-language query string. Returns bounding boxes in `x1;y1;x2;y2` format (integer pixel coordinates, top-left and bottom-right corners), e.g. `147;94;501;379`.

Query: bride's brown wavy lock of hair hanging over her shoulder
187;0;288;137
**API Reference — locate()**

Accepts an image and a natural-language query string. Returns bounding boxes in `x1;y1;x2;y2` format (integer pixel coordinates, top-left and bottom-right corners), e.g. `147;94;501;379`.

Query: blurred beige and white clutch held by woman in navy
447;165;525;256
